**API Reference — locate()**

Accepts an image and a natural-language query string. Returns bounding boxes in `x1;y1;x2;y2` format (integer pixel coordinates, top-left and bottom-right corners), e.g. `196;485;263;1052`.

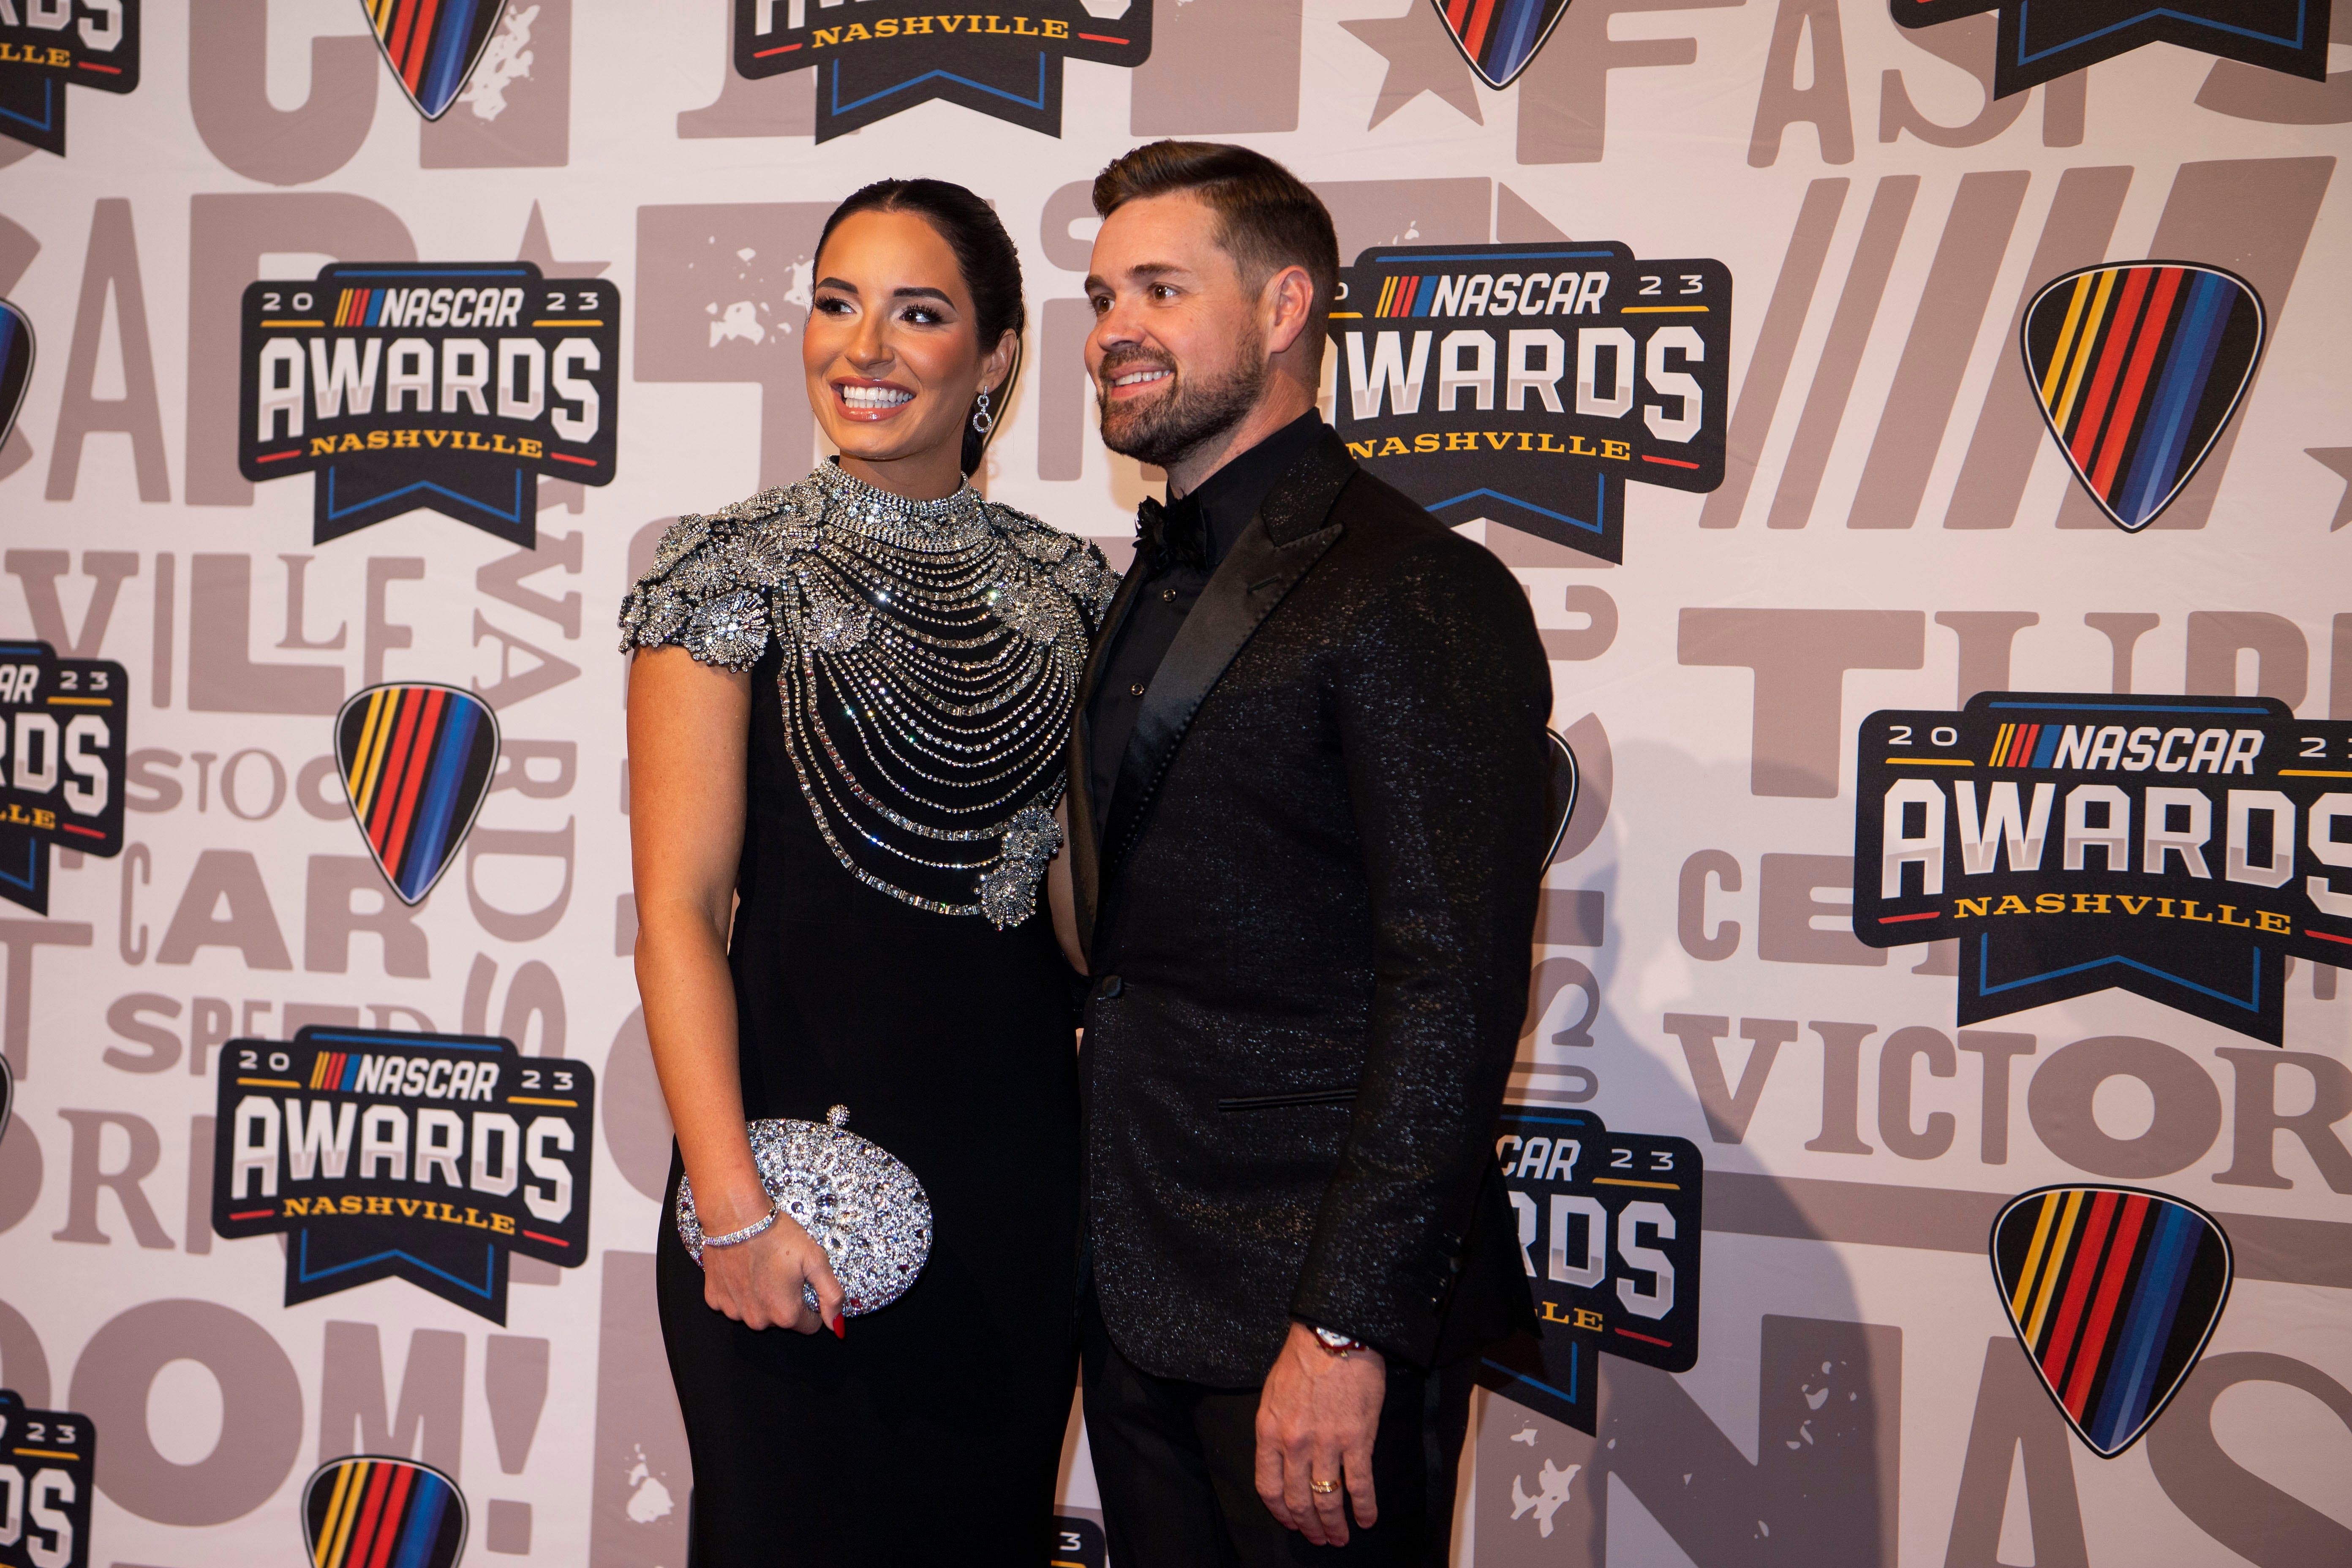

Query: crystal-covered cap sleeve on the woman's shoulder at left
621;484;816;670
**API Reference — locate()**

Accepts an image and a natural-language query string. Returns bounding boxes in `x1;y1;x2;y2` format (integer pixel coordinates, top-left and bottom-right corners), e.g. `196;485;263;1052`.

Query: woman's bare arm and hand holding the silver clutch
628;649;842;1333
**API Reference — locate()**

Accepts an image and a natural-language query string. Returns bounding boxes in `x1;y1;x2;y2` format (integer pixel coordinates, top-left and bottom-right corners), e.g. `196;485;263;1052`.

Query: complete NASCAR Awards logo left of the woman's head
237;261;621;548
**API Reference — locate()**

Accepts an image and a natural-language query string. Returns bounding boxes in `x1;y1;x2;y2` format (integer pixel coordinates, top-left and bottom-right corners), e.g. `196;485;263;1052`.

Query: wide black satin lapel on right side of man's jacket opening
1096;430;1355;858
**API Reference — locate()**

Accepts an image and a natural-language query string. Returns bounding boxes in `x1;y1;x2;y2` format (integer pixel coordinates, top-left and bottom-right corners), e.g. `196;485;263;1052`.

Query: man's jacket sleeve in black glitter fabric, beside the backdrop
1291;524;1550;1366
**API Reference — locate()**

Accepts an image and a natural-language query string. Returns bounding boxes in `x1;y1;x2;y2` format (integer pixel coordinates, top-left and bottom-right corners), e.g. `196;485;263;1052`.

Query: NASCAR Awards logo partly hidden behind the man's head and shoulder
1331;242;1731;562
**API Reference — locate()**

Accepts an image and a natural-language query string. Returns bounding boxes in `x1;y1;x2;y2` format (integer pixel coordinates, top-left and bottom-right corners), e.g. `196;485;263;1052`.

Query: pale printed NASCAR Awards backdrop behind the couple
0;0;2352;1568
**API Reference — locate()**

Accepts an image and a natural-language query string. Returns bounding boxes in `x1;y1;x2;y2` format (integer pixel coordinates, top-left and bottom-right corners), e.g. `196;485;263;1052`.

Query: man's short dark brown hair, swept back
1094;141;1338;357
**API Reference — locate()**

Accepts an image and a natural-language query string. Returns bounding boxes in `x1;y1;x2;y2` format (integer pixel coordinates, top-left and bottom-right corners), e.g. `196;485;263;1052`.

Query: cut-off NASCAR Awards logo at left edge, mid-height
0;642;129;915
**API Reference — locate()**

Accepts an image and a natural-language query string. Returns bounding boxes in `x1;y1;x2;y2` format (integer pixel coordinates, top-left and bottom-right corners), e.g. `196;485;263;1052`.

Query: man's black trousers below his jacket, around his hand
1080;1286;1473;1568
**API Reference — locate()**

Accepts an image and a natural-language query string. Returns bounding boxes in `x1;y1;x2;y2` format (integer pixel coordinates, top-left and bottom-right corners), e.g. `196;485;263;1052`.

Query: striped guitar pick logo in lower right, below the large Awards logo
1992;1187;2230;1460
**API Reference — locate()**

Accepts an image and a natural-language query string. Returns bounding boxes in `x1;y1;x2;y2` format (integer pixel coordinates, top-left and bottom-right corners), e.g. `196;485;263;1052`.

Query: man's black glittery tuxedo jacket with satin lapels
1070;433;1550;1387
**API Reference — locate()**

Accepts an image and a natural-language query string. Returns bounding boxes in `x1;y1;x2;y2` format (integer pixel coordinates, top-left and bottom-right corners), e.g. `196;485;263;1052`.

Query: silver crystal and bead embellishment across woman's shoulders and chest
621;463;1119;926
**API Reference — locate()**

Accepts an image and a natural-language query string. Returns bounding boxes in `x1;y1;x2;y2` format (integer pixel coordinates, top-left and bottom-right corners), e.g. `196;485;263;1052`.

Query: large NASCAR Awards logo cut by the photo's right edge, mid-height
1854;691;2352;1046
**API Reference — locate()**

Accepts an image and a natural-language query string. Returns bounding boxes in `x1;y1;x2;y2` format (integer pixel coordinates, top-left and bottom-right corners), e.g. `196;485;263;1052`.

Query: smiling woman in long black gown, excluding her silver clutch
621;181;1115;1568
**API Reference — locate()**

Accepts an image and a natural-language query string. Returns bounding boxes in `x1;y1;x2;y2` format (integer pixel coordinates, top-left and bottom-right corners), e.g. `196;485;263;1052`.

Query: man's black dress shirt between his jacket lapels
1086;409;1322;839
